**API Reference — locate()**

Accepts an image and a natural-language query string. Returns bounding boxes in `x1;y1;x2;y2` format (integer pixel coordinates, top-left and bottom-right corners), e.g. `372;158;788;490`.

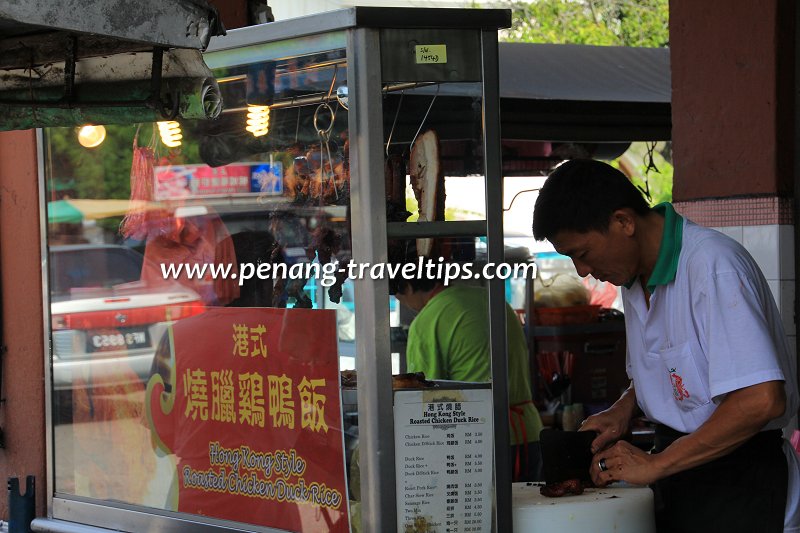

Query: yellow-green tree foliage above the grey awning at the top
503;0;669;47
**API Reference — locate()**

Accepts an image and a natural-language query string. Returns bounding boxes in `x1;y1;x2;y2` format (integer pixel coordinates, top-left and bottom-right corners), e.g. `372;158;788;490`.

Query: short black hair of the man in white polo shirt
533;159;650;241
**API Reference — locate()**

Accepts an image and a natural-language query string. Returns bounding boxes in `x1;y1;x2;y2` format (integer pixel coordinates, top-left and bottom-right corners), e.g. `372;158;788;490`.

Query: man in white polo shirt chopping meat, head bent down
533;160;800;533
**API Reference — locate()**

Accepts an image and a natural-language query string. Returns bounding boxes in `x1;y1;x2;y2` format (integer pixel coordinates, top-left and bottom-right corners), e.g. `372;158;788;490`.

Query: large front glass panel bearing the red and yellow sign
45;42;355;531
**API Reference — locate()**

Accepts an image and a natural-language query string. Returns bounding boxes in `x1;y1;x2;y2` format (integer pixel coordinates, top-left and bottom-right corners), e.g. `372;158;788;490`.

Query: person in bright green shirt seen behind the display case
392;272;542;481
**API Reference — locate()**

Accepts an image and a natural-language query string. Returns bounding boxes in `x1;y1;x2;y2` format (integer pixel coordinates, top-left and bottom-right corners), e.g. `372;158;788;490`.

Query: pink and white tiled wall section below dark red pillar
675;198;797;428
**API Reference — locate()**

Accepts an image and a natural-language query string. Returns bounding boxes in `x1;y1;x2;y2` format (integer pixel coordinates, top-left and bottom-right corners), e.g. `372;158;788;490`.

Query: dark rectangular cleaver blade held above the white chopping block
539;428;597;484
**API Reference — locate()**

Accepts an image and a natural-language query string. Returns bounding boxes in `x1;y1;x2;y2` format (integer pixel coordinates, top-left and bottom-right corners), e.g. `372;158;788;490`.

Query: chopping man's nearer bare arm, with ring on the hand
591;381;786;486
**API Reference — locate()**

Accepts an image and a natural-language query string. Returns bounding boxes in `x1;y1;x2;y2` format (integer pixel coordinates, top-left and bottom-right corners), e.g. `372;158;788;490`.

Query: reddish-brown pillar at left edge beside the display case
0;130;48;519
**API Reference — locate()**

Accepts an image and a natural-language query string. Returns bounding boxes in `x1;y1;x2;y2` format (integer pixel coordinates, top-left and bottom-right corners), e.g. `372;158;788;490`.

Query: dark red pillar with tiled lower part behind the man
670;0;797;427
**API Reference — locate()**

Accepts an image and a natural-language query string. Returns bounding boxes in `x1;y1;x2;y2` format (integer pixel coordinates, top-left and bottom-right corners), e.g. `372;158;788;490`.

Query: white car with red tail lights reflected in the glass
49;244;205;395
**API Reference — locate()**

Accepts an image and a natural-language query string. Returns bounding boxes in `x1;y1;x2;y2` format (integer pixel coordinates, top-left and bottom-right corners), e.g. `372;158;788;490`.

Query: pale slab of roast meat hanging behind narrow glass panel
409;130;444;257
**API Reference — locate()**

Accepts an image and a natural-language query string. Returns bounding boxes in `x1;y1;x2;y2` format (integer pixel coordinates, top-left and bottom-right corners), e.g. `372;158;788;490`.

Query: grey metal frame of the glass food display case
34;7;512;533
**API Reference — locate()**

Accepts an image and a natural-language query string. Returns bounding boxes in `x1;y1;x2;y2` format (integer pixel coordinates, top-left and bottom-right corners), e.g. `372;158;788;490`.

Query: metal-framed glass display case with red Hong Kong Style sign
40;7;511;532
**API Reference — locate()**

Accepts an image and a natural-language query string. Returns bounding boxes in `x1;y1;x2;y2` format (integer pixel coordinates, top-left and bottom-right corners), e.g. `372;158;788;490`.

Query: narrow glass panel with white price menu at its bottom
381;30;510;531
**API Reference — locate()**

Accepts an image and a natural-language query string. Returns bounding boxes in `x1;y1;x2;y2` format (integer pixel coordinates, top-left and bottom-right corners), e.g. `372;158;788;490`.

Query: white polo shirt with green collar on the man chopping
622;208;798;433
